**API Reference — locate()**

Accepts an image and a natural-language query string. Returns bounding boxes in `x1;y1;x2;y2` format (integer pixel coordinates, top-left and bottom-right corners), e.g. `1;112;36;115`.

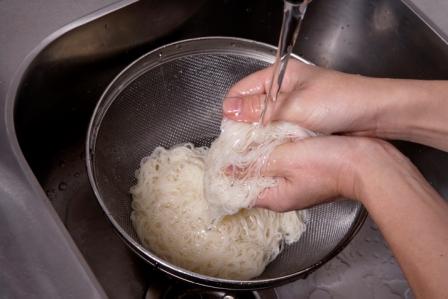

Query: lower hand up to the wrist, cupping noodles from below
255;136;356;212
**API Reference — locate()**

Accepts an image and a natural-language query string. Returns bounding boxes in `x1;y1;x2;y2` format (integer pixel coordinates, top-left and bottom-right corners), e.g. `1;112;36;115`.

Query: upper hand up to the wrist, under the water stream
223;60;384;135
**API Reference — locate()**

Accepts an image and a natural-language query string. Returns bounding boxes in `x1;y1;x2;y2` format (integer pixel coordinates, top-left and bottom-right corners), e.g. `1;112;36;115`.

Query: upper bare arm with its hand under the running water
224;61;448;151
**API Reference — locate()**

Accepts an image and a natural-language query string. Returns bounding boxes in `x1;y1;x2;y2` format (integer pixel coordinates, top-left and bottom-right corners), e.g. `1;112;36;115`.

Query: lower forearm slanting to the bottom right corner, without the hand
359;144;448;298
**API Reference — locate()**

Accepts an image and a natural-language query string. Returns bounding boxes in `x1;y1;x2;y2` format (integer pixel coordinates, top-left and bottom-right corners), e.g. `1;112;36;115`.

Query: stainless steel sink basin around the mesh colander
10;0;448;298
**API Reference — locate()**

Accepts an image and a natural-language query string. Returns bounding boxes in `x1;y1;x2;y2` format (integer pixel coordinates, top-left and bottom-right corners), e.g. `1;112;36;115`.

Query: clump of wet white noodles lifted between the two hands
204;119;315;219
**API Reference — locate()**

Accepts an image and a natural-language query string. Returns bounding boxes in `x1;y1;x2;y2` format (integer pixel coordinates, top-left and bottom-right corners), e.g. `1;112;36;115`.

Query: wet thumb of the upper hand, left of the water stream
223;94;266;123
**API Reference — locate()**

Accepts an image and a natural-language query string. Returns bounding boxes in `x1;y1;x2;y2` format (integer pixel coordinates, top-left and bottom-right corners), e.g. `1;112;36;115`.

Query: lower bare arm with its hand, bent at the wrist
256;136;448;298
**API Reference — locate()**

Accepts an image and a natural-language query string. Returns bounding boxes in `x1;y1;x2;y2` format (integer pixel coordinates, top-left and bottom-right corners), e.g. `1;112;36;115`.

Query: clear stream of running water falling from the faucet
259;0;311;125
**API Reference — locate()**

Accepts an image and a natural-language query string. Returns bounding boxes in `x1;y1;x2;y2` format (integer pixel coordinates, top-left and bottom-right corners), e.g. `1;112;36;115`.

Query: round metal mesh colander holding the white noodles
87;37;366;289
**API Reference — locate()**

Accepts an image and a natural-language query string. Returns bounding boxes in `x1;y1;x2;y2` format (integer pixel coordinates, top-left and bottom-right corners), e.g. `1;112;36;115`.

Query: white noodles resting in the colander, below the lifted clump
131;144;305;280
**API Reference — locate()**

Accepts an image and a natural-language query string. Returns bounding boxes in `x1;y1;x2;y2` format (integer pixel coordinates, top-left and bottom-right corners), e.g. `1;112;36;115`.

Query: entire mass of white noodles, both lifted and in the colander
131;121;312;280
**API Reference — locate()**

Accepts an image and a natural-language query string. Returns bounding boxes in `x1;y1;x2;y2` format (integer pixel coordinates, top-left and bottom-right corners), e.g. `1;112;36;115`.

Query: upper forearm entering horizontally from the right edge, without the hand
373;79;448;151
